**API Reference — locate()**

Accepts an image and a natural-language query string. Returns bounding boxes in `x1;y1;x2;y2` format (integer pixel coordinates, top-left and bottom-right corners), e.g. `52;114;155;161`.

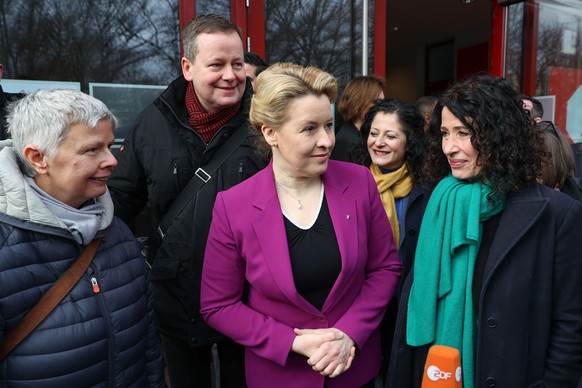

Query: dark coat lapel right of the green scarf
483;186;548;285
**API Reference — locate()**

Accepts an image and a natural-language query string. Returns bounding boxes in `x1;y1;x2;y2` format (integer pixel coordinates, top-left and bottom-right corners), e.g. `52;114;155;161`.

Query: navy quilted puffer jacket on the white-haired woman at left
0;144;165;388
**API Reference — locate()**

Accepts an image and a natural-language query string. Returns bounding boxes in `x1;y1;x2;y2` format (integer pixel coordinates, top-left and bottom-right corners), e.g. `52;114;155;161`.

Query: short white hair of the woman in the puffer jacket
7;89;117;176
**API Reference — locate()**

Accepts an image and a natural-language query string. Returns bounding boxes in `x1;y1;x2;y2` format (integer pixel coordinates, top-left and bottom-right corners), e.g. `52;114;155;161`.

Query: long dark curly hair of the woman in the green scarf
423;74;544;196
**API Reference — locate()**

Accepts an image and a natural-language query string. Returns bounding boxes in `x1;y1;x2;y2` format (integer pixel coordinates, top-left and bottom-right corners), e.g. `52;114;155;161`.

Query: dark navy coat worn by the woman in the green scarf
386;185;582;388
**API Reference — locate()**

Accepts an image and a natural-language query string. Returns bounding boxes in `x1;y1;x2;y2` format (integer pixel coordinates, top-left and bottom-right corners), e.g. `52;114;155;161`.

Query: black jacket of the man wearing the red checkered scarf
108;77;268;346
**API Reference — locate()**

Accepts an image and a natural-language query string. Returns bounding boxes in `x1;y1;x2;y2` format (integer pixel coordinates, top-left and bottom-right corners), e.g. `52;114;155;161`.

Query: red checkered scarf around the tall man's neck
186;82;242;143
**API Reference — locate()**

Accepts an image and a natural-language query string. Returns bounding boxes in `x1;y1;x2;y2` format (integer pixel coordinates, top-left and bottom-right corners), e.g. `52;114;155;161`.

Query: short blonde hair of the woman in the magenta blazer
249;62;337;156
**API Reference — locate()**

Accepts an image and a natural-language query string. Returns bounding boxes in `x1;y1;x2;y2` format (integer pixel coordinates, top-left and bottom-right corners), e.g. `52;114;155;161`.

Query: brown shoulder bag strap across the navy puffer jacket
0;238;102;362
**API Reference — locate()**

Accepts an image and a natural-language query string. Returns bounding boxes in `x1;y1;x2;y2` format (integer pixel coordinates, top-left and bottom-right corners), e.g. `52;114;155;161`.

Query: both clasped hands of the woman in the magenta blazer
291;328;356;378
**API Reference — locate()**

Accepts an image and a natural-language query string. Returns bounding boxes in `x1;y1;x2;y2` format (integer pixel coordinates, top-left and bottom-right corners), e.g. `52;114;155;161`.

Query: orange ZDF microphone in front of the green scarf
421;345;463;388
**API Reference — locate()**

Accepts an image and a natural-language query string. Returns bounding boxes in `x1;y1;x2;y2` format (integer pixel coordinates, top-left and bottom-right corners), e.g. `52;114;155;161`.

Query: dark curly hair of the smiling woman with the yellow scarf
349;98;426;182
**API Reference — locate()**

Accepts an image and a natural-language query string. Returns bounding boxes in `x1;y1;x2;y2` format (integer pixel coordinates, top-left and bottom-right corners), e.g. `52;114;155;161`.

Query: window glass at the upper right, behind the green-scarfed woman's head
505;0;582;142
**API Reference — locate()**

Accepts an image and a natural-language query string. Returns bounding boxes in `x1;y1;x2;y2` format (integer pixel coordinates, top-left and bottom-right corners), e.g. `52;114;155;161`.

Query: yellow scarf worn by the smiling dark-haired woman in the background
370;163;412;246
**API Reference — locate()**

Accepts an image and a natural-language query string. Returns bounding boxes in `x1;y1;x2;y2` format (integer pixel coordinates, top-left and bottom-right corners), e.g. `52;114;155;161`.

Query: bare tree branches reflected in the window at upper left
0;0;179;89
